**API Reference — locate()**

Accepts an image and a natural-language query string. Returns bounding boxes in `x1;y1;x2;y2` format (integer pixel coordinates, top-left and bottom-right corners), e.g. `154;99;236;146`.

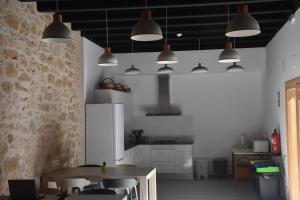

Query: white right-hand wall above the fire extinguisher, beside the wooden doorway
262;10;300;198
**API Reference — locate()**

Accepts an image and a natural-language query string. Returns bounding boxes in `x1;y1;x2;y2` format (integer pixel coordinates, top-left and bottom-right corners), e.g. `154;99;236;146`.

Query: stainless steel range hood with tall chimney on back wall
146;74;181;116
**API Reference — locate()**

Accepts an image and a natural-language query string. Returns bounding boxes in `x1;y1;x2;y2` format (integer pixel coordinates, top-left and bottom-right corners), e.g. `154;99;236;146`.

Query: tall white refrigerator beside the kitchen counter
85;104;124;166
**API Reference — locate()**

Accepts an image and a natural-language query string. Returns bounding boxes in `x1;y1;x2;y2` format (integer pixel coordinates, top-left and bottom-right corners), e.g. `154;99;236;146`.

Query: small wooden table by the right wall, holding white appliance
232;148;271;183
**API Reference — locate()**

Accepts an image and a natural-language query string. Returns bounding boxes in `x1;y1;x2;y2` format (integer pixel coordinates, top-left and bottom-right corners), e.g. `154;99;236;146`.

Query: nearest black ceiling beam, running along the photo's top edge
37;0;286;13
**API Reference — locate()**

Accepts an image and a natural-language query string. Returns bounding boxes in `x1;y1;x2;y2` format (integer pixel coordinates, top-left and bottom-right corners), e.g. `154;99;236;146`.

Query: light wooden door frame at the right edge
285;77;300;200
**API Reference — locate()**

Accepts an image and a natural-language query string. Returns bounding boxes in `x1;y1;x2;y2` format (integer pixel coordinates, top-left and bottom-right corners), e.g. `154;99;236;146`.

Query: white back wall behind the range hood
114;48;265;172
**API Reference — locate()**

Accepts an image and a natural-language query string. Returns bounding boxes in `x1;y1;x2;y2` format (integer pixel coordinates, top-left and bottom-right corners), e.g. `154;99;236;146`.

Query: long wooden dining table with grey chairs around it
42;167;157;200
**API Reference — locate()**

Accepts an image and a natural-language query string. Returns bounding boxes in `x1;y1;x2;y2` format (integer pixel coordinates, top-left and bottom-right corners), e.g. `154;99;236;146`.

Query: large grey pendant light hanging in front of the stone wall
42;0;72;43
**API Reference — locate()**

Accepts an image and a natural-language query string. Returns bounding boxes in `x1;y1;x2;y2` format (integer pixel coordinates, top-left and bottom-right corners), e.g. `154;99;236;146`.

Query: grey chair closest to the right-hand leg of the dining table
103;179;138;200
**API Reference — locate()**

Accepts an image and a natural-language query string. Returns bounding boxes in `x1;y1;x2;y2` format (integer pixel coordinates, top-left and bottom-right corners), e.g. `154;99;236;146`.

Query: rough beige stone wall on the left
0;0;82;195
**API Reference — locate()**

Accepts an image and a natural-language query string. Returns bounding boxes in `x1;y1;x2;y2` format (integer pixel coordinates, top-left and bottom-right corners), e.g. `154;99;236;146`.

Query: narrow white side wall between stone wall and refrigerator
81;37;111;163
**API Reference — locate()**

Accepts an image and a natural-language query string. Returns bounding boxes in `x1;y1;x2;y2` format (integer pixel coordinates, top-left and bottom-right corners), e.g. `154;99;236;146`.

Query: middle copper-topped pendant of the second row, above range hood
156;8;178;65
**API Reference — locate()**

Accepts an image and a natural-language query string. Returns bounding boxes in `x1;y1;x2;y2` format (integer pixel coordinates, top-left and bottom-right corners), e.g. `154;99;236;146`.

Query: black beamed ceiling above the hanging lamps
20;0;299;53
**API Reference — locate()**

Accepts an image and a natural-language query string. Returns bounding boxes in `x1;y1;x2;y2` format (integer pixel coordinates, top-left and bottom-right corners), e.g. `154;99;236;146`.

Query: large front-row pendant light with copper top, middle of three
131;0;163;41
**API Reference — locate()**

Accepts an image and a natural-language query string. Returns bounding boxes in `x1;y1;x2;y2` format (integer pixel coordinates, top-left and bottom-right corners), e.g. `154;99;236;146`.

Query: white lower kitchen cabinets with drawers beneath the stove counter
121;145;193;175
